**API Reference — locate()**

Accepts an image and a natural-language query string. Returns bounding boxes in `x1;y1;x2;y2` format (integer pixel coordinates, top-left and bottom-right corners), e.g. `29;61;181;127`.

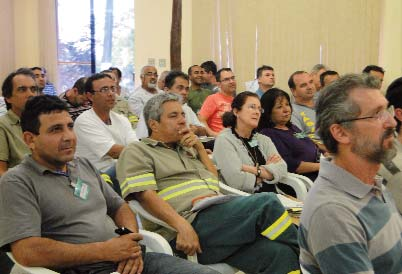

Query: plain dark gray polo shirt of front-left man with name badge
0;156;124;250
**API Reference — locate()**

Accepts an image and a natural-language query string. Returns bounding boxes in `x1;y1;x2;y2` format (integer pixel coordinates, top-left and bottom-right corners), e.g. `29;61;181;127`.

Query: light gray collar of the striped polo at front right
318;158;382;199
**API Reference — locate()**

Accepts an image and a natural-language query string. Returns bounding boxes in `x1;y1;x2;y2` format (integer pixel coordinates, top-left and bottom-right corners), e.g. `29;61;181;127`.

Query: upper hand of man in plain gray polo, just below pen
104;233;142;262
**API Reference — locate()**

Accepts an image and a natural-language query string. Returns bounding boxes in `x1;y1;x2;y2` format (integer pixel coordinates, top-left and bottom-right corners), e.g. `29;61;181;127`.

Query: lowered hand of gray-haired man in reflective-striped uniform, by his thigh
176;221;202;256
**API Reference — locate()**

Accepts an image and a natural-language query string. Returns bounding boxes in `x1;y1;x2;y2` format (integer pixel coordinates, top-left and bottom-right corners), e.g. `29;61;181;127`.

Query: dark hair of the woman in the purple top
258;88;293;130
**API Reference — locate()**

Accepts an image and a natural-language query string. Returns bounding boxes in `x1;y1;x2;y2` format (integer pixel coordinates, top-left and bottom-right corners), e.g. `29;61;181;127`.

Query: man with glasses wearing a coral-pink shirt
198;68;236;137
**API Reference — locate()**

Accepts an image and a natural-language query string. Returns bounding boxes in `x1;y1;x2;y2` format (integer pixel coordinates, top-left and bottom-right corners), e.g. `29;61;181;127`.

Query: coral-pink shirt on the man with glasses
199;92;233;132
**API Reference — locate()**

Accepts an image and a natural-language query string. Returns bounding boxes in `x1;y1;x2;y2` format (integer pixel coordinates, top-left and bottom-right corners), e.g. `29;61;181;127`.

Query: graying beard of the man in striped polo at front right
351;128;396;164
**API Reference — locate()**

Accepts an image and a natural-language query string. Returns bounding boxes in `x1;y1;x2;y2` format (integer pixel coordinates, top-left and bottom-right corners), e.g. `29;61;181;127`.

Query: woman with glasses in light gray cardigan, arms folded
213;91;287;193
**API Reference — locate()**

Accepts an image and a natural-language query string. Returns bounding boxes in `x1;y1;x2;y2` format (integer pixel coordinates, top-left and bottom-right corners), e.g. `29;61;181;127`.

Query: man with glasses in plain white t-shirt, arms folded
74;73;137;193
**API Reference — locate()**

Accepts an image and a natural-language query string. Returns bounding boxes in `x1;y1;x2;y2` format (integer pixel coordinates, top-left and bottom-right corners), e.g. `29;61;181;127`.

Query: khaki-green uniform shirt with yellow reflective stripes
116;138;219;240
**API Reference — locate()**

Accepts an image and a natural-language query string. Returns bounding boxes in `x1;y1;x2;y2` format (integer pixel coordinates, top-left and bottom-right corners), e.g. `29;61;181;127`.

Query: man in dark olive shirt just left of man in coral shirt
188;65;213;113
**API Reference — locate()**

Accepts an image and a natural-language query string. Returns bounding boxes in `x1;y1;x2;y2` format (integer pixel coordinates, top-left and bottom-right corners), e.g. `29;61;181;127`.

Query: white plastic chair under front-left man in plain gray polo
7;229;173;274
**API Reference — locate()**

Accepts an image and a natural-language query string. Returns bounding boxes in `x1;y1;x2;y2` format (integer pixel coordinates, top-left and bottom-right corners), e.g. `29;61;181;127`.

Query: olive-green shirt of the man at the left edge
0;109;31;168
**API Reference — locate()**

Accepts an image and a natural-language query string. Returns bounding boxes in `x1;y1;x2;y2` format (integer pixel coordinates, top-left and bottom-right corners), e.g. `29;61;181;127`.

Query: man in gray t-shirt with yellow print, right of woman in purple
288;71;322;148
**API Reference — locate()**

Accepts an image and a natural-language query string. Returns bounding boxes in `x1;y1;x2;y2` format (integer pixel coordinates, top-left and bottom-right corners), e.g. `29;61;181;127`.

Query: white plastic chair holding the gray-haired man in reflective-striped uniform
129;200;238;274
